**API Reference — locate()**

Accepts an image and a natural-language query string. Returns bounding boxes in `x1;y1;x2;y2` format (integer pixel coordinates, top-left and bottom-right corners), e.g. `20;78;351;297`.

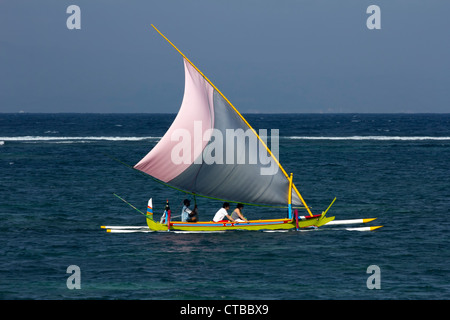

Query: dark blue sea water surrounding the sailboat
0;114;450;300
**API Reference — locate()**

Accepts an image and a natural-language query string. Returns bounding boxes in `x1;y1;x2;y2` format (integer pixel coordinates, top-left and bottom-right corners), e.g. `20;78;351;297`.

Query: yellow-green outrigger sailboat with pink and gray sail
108;25;382;232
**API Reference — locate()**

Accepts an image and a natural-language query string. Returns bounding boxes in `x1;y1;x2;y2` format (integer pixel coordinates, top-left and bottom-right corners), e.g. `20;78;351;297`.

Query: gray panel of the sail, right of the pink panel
169;90;301;205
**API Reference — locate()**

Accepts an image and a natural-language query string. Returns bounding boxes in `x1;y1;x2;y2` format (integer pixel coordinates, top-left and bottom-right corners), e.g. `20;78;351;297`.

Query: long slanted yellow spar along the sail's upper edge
151;24;313;216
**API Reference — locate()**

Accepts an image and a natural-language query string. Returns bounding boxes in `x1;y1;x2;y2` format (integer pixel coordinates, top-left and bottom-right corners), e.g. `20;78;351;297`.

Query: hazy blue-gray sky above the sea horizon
0;0;450;113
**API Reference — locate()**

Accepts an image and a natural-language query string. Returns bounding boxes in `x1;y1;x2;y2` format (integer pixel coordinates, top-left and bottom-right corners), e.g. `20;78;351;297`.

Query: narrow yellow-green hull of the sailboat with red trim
147;215;334;231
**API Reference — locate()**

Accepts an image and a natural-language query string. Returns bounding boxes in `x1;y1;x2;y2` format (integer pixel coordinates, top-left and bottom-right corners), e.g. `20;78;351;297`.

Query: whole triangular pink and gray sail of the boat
134;58;302;206
